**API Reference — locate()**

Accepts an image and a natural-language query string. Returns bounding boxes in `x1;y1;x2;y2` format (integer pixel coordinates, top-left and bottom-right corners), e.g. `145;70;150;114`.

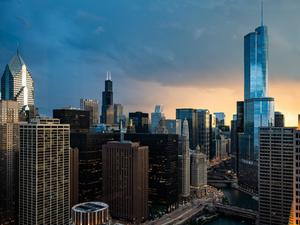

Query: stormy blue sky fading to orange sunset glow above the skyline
0;0;300;126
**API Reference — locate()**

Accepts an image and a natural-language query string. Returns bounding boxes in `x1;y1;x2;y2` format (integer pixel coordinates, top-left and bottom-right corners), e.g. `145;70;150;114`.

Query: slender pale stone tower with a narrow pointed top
181;119;191;198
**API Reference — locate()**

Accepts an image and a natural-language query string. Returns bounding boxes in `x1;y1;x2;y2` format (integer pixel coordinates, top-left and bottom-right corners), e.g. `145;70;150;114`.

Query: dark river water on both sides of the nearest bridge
207;188;258;225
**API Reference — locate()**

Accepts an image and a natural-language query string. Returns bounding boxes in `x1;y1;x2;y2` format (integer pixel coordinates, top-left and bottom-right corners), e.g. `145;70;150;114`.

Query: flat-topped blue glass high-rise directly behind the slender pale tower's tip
176;108;197;149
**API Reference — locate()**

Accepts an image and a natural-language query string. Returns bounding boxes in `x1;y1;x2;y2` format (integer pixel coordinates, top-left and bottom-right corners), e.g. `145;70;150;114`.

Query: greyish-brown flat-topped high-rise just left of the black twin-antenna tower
80;98;100;126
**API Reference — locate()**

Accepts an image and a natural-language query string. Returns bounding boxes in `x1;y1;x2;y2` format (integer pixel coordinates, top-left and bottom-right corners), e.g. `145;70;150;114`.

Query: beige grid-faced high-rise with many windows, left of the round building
19;119;70;225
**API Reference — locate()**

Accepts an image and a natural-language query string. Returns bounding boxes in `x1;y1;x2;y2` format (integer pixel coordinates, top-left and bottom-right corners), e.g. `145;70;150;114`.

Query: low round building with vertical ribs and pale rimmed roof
72;202;110;225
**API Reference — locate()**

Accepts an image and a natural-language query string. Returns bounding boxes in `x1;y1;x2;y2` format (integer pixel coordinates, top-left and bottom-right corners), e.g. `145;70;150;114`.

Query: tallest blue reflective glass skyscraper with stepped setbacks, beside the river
239;7;274;192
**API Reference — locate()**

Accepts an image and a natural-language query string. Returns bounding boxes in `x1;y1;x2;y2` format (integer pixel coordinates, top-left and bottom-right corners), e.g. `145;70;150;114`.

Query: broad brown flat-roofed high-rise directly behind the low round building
102;141;148;224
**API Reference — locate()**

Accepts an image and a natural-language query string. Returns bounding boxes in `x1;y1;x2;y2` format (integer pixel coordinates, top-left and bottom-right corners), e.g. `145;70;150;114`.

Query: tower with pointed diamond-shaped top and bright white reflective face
1;50;34;112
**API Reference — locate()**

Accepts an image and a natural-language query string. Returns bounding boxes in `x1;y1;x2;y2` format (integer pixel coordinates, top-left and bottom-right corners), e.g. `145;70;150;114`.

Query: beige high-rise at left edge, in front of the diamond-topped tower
0;100;19;224
